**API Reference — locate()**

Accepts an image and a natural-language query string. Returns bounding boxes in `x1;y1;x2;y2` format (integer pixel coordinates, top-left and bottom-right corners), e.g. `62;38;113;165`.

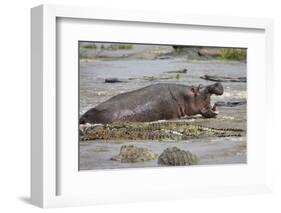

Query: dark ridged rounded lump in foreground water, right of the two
158;147;199;166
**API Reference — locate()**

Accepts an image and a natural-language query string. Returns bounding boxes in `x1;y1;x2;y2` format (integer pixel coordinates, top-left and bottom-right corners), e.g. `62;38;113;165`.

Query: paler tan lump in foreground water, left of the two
111;145;157;163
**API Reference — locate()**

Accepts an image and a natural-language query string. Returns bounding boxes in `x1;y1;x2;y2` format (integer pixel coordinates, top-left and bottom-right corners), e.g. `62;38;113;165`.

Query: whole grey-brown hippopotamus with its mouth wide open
79;83;223;124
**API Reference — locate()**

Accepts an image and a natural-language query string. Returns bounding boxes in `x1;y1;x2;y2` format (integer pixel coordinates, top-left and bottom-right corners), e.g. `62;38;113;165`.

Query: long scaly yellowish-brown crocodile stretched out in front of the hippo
80;121;243;141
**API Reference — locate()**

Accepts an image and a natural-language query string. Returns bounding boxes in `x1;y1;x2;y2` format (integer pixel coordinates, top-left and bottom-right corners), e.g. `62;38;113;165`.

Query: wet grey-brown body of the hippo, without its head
81;84;186;123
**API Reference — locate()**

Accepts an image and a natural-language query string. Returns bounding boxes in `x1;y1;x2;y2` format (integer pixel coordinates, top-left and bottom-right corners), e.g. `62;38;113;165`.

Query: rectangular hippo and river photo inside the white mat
79;41;247;170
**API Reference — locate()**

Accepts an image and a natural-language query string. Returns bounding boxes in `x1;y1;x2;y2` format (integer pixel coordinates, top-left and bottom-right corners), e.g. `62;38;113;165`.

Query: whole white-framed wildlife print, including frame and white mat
31;5;273;207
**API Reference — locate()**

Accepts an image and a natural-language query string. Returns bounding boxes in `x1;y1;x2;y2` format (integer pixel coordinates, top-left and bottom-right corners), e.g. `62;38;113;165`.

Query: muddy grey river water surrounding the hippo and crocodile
79;45;247;170
